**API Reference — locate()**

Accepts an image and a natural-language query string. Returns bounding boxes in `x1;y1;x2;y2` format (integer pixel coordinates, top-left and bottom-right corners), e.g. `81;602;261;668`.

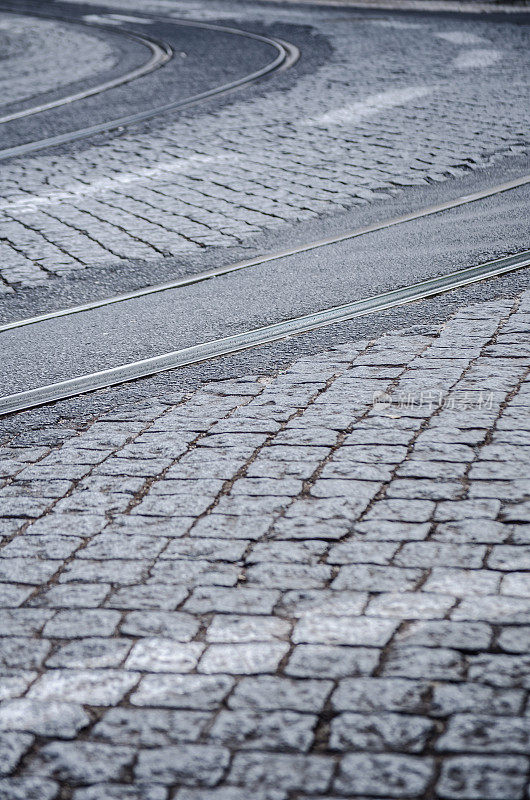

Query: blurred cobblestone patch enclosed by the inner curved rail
0;13;116;105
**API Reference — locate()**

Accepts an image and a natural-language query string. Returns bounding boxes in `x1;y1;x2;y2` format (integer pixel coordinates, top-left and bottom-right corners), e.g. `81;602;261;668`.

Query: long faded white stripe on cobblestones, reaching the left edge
0;153;233;211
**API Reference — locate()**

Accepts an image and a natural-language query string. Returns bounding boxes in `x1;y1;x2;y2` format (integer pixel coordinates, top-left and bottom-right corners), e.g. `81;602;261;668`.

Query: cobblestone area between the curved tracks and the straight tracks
0;2;530;293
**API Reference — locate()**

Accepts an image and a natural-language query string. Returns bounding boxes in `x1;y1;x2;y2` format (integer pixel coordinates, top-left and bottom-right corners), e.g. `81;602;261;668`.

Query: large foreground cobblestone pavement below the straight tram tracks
0;291;530;800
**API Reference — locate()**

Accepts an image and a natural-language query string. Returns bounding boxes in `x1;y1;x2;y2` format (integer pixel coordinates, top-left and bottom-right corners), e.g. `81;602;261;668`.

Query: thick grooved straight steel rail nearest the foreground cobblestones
0;250;530;416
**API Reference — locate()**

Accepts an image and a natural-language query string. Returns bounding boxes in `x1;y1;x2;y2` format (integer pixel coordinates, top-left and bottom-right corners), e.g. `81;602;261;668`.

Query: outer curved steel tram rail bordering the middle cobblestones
0;9;300;161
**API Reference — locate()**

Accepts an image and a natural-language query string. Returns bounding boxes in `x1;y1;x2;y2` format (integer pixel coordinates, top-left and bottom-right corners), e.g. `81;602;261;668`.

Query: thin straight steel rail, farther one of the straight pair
0;175;530;333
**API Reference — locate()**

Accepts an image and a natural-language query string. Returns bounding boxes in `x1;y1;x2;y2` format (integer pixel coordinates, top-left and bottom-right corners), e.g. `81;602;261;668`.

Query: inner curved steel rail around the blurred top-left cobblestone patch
0;14;173;124
